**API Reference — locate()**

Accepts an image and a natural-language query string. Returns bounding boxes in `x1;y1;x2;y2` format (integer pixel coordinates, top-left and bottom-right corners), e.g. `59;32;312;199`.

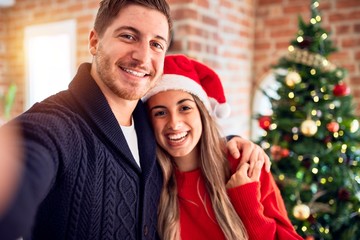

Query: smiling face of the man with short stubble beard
90;5;169;100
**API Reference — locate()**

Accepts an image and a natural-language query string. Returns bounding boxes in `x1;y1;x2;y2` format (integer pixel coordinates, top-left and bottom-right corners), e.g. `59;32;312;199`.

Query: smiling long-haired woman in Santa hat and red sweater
143;55;302;240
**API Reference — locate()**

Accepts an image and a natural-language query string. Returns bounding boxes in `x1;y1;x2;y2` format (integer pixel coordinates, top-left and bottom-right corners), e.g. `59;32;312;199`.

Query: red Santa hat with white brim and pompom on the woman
142;55;230;118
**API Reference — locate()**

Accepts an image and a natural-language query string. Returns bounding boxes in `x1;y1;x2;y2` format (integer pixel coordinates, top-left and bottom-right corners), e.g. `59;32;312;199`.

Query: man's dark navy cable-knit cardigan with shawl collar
0;63;162;240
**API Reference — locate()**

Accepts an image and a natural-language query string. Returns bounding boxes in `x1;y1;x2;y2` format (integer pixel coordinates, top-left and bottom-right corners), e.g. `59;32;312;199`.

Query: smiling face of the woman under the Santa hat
147;90;202;170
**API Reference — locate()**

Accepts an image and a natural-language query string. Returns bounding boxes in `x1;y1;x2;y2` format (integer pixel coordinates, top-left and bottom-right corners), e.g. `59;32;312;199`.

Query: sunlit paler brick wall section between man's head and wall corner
169;0;255;136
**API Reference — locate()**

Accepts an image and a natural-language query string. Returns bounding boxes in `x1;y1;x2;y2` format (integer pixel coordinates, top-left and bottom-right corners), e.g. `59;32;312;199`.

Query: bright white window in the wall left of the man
25;20;76;108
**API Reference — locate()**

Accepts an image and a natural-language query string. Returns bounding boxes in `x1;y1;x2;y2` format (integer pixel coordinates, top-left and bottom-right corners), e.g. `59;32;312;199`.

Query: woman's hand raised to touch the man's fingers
226;159;264;188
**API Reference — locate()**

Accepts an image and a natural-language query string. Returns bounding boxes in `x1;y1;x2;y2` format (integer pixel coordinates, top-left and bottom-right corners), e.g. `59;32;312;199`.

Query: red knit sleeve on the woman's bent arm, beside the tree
228;158;303;240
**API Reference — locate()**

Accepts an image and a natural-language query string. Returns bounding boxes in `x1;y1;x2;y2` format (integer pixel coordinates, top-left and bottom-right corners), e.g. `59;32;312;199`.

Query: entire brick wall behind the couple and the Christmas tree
0;0;360;137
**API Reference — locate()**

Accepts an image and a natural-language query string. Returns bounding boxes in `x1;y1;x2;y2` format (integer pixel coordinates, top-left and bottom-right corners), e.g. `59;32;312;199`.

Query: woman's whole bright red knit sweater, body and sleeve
176;156;303;240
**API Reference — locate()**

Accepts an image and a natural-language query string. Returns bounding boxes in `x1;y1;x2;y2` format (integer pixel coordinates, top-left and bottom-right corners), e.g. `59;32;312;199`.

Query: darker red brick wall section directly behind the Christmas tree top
254;0;360;115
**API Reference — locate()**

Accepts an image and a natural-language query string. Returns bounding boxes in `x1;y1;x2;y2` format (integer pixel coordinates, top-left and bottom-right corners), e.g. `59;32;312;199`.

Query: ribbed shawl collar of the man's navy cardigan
69;63;155;173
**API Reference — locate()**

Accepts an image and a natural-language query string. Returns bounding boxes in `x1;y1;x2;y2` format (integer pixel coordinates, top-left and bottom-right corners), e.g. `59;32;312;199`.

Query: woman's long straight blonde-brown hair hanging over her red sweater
157;95;248;240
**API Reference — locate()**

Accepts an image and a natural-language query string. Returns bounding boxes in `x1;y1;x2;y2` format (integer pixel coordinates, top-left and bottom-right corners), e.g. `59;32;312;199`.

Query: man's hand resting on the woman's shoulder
226;137;271;177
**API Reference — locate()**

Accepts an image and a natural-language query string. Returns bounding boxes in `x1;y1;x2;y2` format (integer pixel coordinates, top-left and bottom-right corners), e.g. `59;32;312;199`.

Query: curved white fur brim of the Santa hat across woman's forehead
142;74;212;113
